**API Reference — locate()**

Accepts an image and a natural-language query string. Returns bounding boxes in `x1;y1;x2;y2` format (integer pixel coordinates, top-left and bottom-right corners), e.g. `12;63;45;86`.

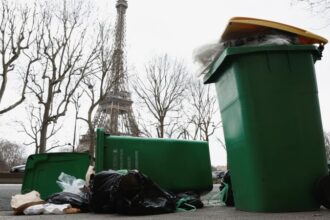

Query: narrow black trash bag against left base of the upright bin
220;170;235;206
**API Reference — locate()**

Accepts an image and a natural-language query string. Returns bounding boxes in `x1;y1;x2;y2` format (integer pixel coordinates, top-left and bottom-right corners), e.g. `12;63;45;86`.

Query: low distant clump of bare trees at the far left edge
0;140;25;167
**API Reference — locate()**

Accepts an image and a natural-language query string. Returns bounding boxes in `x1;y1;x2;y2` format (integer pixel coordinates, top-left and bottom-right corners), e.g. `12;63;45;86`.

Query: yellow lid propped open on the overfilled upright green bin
220;17;328;44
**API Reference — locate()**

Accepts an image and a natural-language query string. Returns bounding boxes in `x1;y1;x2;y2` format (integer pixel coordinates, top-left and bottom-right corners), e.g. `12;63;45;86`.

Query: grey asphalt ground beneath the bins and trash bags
0;184;330;220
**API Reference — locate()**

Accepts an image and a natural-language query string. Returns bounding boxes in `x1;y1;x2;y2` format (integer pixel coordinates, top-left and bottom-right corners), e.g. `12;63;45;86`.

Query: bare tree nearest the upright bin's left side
180;80;221;141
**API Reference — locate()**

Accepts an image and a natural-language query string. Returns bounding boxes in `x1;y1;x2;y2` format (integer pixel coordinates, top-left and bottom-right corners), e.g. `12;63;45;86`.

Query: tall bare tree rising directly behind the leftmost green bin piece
18;1;96;153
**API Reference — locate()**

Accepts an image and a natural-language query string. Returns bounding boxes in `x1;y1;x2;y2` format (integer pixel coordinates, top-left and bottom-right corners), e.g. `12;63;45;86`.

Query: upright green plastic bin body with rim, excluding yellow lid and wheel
204;46;327;212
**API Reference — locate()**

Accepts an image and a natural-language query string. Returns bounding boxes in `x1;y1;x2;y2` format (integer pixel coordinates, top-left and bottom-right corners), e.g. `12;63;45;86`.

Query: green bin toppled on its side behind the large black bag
95;129;213;192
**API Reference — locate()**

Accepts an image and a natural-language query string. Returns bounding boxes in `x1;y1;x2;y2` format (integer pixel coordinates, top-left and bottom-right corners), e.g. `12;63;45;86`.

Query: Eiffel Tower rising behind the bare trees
79;0;140;149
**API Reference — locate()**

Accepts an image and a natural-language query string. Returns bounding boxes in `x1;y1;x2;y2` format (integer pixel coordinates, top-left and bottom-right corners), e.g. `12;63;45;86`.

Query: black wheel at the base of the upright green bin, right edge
316;174;330;209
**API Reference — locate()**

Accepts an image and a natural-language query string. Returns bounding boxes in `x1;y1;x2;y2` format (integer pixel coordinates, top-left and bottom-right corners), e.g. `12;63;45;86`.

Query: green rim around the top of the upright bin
204;45;321;84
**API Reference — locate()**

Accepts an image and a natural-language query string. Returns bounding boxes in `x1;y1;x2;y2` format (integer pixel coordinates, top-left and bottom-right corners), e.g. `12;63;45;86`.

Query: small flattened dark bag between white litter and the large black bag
47;192;89;212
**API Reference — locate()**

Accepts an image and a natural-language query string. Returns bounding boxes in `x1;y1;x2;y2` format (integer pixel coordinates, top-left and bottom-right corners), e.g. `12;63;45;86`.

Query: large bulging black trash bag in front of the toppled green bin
90;170;175;215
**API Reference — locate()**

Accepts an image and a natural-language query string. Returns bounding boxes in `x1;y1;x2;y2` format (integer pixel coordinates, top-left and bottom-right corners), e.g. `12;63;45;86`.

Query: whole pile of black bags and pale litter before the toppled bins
11;170;203;215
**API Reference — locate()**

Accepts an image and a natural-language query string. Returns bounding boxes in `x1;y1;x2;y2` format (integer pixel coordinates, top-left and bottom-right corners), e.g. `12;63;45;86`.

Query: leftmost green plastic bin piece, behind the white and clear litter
21;153;89;200
